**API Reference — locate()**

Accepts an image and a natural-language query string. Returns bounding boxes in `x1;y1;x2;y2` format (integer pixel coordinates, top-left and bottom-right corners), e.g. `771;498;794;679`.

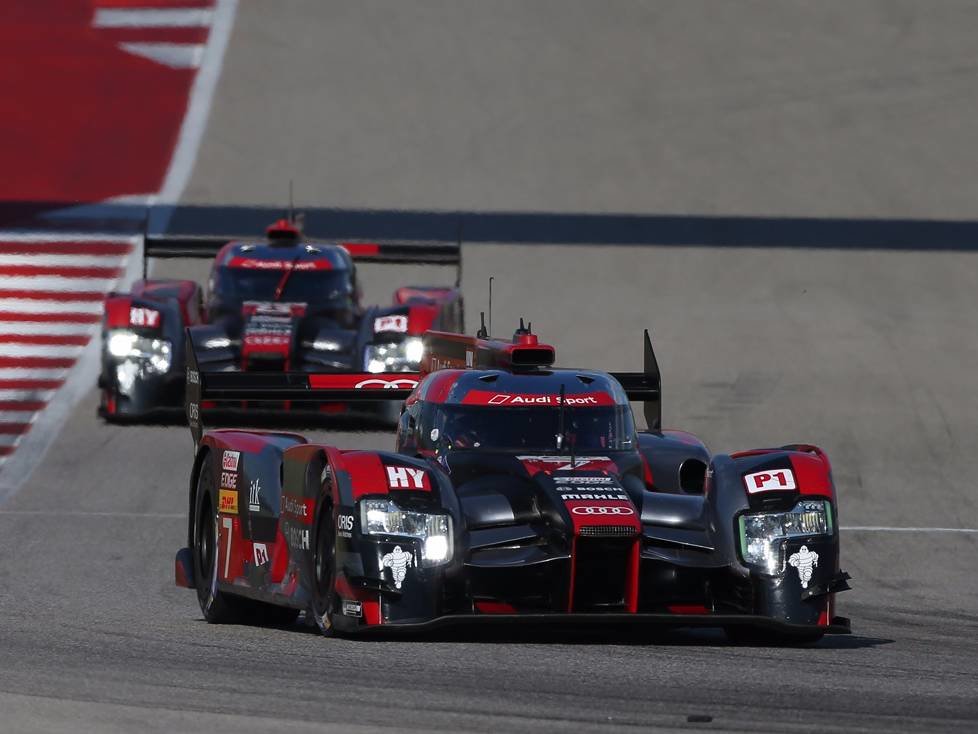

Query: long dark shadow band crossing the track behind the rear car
0;201;978;252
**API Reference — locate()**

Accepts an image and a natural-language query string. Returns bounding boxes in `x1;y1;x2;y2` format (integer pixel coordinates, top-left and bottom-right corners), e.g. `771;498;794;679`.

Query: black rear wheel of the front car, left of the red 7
193;454;245;624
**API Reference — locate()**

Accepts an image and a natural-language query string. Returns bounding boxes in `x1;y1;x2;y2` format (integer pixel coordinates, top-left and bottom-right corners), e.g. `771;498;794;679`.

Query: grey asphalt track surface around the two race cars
0;0;978;732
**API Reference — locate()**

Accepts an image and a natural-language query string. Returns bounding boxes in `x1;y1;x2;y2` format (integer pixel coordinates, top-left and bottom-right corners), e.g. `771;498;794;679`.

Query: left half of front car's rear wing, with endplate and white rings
184;328;421;447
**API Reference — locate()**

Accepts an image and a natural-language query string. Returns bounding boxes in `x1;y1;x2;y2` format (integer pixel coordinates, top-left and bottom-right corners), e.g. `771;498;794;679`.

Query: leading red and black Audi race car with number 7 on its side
176;323;850;643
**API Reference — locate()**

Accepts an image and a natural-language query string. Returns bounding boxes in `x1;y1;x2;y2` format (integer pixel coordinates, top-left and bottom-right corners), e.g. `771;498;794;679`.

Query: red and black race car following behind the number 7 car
98;218;464;421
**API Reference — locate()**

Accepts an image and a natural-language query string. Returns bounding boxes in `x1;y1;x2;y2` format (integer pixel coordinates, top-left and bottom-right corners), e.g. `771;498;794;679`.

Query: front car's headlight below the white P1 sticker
740;500;833;575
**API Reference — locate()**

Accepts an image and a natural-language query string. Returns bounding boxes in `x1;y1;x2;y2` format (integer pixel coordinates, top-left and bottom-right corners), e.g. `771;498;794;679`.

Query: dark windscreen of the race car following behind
213;267;353;308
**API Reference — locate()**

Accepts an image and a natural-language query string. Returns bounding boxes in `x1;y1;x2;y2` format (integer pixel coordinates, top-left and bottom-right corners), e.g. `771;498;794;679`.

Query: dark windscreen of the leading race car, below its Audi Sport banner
421;403;636;454
